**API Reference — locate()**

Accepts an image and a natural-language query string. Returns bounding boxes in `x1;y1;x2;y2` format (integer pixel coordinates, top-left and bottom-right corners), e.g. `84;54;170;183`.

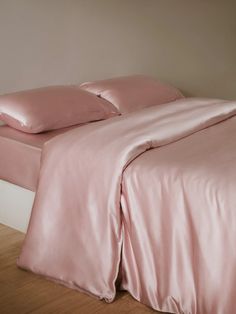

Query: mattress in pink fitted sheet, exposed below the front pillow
0;125;74;191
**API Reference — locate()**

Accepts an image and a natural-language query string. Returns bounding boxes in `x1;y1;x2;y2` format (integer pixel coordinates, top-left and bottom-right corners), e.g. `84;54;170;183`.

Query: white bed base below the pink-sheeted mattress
0;180;35;232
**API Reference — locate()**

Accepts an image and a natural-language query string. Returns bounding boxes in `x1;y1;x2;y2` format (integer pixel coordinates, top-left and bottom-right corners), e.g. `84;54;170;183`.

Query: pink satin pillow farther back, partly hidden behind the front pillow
80;75;184;113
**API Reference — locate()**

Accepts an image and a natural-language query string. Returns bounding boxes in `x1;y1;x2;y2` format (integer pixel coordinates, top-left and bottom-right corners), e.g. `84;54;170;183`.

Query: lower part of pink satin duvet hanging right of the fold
122;117;236;314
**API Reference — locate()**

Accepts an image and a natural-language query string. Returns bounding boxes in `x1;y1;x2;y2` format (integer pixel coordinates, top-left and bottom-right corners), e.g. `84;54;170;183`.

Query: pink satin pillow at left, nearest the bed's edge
0;86;119;133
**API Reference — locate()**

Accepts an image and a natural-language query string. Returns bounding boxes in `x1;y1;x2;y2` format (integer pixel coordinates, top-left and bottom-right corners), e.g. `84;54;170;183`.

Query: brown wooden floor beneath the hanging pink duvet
0;224;164;314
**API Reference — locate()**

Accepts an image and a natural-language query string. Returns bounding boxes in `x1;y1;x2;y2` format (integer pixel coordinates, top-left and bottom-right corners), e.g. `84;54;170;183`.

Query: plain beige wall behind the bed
0;0;236;99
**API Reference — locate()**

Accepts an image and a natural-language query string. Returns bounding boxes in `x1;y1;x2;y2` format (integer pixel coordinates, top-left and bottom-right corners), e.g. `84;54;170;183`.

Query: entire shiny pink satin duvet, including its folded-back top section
18;99;236;314
